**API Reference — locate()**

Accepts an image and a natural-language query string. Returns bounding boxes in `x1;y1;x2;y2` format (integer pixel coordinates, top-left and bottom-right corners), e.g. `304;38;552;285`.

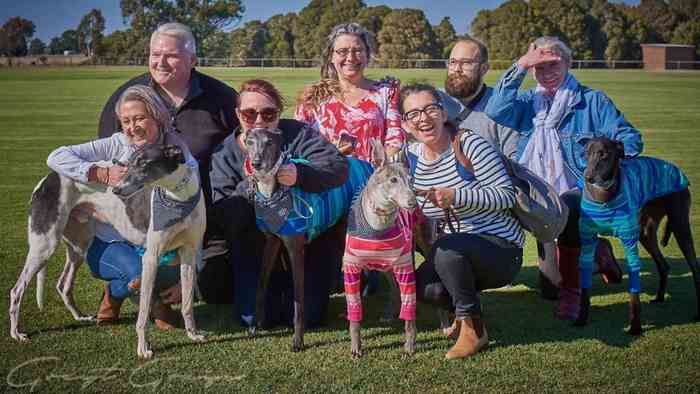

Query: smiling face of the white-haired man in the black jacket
148;34;197;89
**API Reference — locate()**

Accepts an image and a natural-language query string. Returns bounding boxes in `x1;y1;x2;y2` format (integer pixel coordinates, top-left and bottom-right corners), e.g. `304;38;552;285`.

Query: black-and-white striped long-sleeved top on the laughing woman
408;131;525;247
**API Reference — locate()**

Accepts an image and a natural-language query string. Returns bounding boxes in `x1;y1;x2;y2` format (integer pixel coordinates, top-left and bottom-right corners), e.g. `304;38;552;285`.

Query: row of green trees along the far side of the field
0;0;700;67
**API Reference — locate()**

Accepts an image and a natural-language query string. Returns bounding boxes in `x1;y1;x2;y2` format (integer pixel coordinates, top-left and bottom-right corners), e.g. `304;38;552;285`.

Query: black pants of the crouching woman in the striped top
416;233;523;318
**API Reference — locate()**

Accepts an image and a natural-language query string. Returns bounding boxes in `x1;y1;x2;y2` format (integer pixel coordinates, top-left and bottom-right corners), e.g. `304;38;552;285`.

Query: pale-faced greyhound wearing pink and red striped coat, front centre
343;140;416;357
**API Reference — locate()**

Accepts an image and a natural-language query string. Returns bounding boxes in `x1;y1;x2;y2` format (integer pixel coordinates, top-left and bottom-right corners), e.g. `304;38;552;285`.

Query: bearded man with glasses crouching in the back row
440;38;519;159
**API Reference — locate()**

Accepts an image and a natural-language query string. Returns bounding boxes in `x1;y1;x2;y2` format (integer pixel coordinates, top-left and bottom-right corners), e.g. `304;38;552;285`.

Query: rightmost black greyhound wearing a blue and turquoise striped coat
575;138;700;335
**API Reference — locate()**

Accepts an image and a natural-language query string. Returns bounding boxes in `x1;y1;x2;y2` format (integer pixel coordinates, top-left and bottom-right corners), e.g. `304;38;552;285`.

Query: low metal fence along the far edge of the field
0;55;700;70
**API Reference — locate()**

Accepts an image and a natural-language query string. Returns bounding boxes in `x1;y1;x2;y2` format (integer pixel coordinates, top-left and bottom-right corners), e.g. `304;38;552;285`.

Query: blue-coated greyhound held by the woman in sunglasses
245;128;372;351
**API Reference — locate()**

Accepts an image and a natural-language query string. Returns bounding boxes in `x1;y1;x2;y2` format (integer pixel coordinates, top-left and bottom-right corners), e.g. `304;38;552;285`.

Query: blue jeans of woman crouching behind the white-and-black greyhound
87;238;180;300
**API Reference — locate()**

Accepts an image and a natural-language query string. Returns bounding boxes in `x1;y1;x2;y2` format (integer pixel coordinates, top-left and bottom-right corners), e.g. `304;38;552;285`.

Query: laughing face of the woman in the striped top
401;91;447;146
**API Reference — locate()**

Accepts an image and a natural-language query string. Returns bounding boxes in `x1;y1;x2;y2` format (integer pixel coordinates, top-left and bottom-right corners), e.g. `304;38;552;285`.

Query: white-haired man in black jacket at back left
98;23;238;320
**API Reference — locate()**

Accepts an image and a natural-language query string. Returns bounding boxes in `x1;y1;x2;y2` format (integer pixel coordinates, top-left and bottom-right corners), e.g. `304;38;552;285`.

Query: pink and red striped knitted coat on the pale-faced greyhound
343;205;417;322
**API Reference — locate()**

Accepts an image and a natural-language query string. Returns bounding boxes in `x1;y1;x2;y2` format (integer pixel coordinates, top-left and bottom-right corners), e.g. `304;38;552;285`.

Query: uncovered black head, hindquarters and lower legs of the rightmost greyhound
575;138;700;335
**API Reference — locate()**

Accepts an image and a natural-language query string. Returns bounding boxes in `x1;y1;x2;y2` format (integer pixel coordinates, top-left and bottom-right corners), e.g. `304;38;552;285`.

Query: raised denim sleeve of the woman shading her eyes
484;64;534;132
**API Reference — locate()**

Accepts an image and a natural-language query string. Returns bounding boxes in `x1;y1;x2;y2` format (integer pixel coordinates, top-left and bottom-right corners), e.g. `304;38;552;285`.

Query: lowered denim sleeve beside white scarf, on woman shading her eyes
596;92;644;158
